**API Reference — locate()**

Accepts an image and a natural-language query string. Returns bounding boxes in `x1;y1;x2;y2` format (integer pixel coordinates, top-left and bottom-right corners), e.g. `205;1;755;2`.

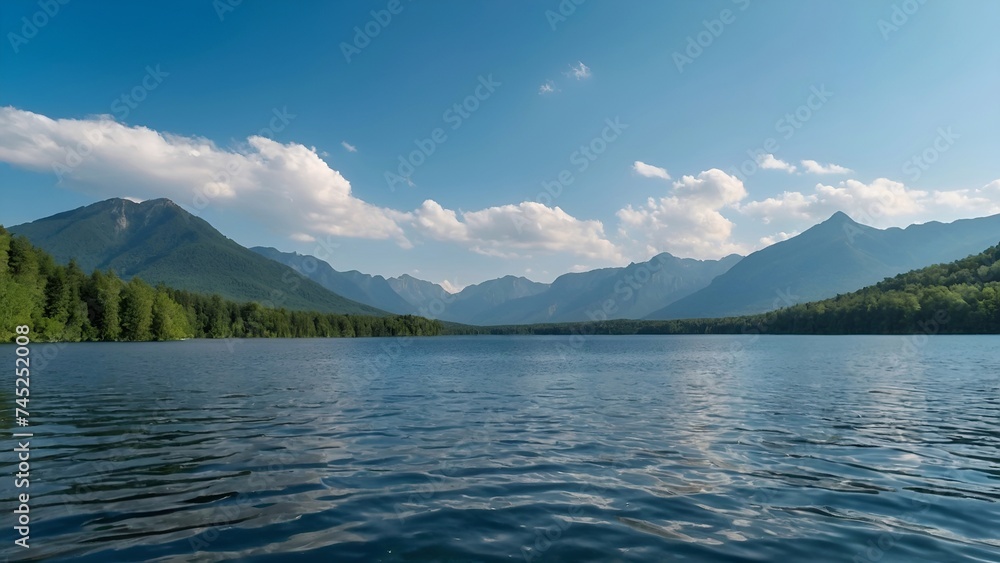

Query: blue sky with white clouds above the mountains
0;0;1000;287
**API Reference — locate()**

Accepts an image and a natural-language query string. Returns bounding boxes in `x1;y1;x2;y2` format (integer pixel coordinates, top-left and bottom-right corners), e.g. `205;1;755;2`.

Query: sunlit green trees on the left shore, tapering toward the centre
0;227;441;342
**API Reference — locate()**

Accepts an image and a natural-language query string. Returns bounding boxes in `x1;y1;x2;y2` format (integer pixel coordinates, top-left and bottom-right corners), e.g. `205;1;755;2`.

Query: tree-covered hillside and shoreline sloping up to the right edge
446;242;1000;335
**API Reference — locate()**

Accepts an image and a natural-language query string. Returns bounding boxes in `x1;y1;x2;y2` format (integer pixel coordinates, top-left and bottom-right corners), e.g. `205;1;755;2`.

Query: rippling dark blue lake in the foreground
0;336;1000;563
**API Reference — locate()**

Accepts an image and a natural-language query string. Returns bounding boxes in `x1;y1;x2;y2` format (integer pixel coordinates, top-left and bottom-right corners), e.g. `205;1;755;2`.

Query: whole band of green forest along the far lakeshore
7;223;1000;342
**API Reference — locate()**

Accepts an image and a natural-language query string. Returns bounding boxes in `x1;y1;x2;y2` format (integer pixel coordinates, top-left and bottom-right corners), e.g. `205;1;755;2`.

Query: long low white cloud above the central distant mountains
412;200;622;261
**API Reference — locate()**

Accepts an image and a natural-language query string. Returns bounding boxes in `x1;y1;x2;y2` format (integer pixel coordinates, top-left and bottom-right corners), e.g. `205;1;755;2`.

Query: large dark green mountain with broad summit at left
10;199;385;315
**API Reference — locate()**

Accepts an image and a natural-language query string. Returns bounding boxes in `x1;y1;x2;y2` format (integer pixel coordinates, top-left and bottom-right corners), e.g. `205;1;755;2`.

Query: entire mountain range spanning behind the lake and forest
10;199;1000;325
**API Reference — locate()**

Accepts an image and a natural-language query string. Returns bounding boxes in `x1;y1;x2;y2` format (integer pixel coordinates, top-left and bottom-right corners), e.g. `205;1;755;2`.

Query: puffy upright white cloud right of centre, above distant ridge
617;168;747;258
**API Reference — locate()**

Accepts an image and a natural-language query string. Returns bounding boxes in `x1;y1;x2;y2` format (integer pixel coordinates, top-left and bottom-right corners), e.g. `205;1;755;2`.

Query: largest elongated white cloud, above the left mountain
0;107;410;248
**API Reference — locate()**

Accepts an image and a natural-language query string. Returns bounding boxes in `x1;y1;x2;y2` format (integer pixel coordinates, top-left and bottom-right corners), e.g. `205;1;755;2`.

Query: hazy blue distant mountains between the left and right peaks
251;247;740;325
